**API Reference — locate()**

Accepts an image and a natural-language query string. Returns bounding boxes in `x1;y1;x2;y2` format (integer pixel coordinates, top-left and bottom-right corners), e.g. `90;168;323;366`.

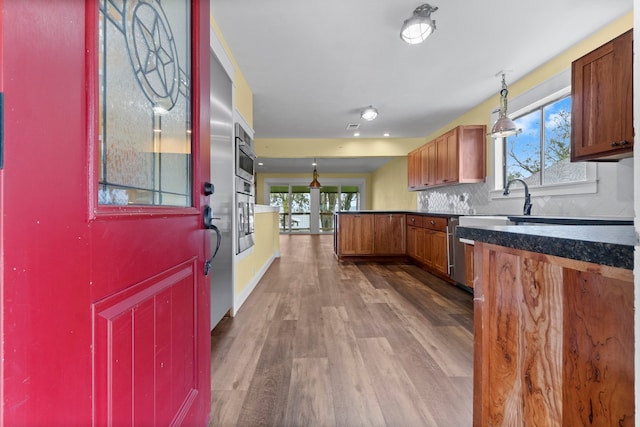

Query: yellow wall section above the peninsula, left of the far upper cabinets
371;156;418;210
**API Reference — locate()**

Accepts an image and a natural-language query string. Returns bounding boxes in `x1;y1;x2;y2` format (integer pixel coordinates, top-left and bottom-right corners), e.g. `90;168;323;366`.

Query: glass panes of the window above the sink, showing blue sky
503;96;586;185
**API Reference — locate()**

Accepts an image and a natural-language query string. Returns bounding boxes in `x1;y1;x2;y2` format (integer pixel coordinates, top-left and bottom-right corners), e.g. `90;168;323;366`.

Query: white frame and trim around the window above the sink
489;69;598;199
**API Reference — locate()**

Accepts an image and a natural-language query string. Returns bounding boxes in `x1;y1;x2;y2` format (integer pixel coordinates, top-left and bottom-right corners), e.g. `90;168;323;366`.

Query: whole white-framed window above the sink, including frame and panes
489;68;598;199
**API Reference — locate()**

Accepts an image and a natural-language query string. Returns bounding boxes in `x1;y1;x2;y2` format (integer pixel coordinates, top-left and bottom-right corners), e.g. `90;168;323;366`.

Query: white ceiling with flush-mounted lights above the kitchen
211;0;633;172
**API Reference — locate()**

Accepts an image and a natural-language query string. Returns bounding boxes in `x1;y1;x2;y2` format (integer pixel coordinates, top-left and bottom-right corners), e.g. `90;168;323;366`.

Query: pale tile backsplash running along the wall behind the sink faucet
418;159;635;217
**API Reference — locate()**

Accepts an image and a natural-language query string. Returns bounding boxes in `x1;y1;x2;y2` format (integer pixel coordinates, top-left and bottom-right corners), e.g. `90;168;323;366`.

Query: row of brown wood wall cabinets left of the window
407;125;487;191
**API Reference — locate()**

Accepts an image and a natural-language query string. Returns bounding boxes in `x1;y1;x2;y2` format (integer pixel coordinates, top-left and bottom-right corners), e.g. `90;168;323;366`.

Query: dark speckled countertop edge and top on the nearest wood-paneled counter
456;225;635;270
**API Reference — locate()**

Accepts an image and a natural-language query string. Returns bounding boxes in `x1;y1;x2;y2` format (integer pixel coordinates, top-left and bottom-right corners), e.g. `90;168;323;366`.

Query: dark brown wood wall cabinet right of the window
571;30;633;161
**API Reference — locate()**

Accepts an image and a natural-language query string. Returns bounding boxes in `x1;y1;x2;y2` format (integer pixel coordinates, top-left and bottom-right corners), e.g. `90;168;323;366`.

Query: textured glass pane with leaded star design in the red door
98;0;192;207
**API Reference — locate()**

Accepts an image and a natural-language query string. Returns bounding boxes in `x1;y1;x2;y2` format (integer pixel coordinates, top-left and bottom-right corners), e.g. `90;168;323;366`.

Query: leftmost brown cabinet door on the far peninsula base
339;214;374;255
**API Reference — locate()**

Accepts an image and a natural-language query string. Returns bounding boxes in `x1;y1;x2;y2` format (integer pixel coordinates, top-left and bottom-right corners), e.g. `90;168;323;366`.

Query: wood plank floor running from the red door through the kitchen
211;235;473;427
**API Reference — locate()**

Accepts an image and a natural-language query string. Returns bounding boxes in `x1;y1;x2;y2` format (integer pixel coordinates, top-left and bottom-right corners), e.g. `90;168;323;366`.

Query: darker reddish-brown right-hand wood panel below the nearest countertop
563;269;635;426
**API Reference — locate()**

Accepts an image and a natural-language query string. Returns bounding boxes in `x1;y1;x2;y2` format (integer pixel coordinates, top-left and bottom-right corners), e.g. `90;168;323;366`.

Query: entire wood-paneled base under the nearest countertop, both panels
473;241;635;427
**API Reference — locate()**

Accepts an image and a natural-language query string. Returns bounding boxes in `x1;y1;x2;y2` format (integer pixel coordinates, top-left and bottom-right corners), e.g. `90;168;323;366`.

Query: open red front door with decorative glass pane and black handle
0;0;210;426
